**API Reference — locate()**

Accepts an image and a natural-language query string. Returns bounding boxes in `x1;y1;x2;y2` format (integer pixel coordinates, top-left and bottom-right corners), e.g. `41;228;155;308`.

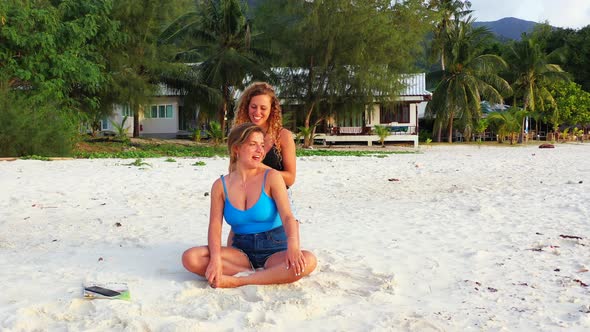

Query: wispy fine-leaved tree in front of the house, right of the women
257;0;428;146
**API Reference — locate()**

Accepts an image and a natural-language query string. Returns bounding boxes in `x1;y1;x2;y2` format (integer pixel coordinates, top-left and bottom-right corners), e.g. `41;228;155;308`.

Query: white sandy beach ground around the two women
0;144;590;331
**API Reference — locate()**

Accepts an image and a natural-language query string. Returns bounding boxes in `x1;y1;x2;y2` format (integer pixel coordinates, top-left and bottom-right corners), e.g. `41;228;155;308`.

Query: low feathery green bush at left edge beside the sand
0;91;79;157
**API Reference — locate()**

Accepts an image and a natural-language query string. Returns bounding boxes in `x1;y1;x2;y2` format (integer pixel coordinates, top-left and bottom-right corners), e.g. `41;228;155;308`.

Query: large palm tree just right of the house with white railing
428;17;511;143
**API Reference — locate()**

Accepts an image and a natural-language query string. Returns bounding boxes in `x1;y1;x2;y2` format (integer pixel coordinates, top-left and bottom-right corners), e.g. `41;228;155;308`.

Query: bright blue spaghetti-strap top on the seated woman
221;170;283;234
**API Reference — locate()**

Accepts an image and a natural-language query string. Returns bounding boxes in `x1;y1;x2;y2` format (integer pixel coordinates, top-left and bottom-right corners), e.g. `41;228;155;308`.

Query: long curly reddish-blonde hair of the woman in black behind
234;82;283;155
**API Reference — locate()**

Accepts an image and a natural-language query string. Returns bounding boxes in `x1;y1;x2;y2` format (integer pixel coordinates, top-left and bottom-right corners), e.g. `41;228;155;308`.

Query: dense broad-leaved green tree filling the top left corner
0;0;120;111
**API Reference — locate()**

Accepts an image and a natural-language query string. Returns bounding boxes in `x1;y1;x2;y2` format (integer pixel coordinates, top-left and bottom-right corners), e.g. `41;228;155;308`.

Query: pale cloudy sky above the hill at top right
471;0;590;29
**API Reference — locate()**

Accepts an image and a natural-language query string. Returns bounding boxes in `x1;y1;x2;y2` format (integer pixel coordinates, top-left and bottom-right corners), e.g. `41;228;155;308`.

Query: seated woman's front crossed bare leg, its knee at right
215;250;317;288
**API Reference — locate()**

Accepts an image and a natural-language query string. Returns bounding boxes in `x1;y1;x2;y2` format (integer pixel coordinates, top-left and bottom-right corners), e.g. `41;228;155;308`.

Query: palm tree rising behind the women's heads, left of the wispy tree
161;0;267;133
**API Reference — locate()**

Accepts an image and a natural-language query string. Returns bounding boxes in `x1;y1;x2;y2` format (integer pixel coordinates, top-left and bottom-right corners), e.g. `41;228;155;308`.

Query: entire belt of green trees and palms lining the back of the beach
0;0;590;158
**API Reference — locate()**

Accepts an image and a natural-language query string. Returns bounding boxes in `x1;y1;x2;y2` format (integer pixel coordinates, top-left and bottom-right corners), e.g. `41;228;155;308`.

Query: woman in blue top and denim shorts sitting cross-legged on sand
182;123;317;288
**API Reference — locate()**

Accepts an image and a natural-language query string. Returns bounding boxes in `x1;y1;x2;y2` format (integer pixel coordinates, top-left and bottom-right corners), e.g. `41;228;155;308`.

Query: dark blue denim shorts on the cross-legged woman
232;226;287;269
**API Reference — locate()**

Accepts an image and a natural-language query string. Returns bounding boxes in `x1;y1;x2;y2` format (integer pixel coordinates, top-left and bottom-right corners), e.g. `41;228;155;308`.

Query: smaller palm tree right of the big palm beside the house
505;38;568;143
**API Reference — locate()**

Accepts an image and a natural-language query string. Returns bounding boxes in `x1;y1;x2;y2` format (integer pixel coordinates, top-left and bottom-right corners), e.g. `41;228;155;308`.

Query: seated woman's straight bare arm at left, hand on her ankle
205;179;225;284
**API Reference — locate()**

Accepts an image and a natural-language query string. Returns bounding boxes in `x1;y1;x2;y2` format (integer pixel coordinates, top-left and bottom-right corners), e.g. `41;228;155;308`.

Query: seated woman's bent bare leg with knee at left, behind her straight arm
182;246;252;277
